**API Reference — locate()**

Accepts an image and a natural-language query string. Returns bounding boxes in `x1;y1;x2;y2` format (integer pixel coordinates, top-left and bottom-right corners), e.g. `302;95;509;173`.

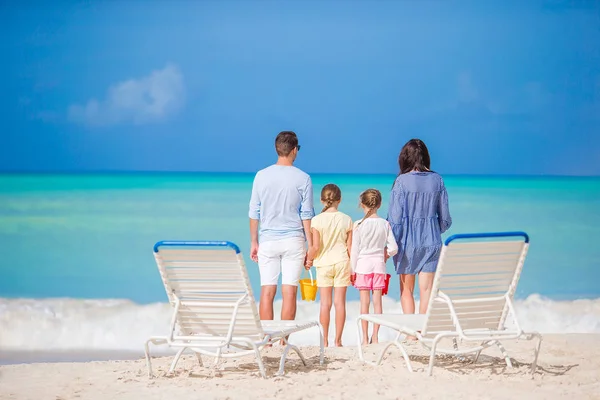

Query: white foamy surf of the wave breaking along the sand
0;294;600;358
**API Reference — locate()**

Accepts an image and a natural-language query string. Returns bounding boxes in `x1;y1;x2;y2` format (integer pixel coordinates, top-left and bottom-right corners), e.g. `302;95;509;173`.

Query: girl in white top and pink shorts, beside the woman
350;189;398;344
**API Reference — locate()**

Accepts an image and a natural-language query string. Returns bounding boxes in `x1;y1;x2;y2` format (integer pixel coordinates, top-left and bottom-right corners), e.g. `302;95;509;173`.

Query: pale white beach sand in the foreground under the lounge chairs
0;334;600;400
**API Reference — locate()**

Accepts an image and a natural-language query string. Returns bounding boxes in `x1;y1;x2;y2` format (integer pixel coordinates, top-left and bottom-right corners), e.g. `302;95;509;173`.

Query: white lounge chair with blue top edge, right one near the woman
357;232;542;375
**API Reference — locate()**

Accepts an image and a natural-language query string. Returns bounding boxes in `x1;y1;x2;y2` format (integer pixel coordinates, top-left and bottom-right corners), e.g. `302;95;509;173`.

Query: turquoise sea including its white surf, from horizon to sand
0;173;600;358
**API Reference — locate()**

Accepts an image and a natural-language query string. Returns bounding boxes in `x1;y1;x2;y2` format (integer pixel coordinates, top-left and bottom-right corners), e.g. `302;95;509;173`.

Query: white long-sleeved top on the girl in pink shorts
350;216;398;274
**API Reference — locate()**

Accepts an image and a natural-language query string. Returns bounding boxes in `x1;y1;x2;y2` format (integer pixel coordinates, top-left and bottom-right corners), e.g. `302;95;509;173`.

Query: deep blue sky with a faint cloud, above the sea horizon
0;0;600;175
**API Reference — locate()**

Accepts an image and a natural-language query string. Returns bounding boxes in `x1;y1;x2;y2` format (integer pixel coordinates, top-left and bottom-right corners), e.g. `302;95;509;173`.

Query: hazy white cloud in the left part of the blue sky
68;64;185;126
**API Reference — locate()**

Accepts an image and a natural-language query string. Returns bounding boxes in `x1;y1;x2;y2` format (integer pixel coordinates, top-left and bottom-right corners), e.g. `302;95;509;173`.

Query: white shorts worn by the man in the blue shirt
258;237;306;286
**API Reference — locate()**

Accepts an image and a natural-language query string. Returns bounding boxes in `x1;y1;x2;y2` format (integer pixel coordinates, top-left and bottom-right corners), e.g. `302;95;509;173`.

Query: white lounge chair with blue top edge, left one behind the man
145;241;324;378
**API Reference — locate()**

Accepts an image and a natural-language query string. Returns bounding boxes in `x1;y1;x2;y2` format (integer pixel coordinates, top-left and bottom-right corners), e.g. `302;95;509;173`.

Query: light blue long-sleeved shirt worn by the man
248;165;315;242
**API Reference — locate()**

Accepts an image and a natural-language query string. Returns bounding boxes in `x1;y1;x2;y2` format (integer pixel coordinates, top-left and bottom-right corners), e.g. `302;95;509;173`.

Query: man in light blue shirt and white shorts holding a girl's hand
248;131;315;320
